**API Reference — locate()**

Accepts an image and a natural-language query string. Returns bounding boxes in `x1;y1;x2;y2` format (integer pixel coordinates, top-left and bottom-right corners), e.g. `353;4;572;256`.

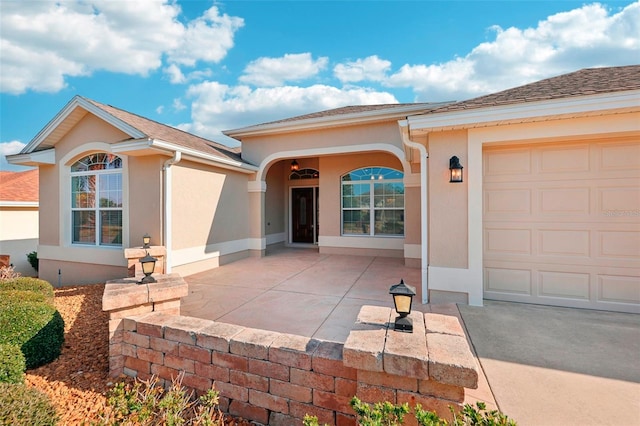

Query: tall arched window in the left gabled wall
71;152;122;246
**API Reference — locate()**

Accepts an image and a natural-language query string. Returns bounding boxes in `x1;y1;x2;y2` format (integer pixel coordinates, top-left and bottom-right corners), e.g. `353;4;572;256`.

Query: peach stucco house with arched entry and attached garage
9;66;640;312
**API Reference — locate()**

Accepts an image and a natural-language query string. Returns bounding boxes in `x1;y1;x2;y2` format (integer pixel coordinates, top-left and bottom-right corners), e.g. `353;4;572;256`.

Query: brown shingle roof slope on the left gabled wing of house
83;98;242;161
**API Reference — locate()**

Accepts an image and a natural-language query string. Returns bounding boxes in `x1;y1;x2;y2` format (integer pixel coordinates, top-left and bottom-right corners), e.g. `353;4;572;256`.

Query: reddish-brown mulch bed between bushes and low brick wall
25;284;249;426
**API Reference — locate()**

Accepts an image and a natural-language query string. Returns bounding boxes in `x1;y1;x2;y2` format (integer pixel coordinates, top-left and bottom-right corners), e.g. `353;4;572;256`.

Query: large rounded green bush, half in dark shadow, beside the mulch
0;290;64;368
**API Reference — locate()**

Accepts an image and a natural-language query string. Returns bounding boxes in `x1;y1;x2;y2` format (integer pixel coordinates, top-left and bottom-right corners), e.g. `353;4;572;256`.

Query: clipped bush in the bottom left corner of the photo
0;383;58;426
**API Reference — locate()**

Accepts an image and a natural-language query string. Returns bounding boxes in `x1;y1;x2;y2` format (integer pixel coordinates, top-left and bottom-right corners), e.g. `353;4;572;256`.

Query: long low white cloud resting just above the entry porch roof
180;81;398;140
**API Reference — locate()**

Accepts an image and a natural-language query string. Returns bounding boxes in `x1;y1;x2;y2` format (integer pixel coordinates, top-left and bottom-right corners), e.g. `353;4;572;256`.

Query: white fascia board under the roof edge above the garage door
407;90;640;132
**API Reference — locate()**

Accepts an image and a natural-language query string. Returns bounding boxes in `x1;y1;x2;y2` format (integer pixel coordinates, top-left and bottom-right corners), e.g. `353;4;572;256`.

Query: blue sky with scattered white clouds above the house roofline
0;0;640;170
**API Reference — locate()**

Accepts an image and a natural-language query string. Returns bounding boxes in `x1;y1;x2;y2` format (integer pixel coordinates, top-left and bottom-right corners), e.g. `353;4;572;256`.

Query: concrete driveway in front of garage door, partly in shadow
458;301;640;426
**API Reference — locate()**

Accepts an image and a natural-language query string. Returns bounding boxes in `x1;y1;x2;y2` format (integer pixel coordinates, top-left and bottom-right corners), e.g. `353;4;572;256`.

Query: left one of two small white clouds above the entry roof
239;53;329;87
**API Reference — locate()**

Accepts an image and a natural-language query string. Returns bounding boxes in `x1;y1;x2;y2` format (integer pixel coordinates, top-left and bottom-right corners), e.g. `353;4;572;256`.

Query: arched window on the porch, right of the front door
342;167;404;236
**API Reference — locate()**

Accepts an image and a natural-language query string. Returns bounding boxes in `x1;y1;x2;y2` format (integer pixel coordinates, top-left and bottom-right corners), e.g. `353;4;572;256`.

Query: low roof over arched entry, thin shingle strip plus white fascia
222;102;450;138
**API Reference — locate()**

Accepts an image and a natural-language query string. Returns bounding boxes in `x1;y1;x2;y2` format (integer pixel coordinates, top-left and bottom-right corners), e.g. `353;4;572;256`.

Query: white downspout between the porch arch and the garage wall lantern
398;120;429;304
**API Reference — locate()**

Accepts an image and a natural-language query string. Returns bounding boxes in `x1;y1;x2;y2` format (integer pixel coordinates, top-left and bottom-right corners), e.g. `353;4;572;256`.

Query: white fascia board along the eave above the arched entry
222;102;451;138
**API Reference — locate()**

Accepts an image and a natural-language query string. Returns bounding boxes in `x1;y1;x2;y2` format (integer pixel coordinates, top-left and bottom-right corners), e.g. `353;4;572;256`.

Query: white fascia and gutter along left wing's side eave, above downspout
113;138;258;174
